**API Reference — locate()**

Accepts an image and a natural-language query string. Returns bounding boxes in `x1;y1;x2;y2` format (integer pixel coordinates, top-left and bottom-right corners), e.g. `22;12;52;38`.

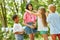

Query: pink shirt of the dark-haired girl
23;12;36;23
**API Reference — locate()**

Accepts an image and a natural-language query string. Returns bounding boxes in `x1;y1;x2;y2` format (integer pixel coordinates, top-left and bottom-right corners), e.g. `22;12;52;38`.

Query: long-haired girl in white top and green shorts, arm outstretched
26;7;48;40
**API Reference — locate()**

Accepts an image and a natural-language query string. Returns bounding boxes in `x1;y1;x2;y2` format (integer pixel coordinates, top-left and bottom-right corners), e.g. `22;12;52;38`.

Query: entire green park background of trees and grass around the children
0;0;60;40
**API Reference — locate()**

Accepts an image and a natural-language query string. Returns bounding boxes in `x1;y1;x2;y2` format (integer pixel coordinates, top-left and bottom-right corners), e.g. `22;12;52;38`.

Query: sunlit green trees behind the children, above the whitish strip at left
0;0;60;39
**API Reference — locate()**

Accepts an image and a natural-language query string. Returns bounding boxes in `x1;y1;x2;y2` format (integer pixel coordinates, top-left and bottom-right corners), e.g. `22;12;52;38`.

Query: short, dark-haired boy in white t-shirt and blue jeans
12;15;24;40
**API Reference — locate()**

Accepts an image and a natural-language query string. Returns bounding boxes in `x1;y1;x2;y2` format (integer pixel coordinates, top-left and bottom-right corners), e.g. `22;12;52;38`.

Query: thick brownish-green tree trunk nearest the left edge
0;0;7;27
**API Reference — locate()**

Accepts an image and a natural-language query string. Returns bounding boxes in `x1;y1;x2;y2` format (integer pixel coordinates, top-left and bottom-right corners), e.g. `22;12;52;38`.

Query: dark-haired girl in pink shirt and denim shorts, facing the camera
24;3;36;40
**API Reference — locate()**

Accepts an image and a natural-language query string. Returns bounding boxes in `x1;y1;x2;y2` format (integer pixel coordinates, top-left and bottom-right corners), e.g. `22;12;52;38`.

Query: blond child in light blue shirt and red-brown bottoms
47;4;60;40
